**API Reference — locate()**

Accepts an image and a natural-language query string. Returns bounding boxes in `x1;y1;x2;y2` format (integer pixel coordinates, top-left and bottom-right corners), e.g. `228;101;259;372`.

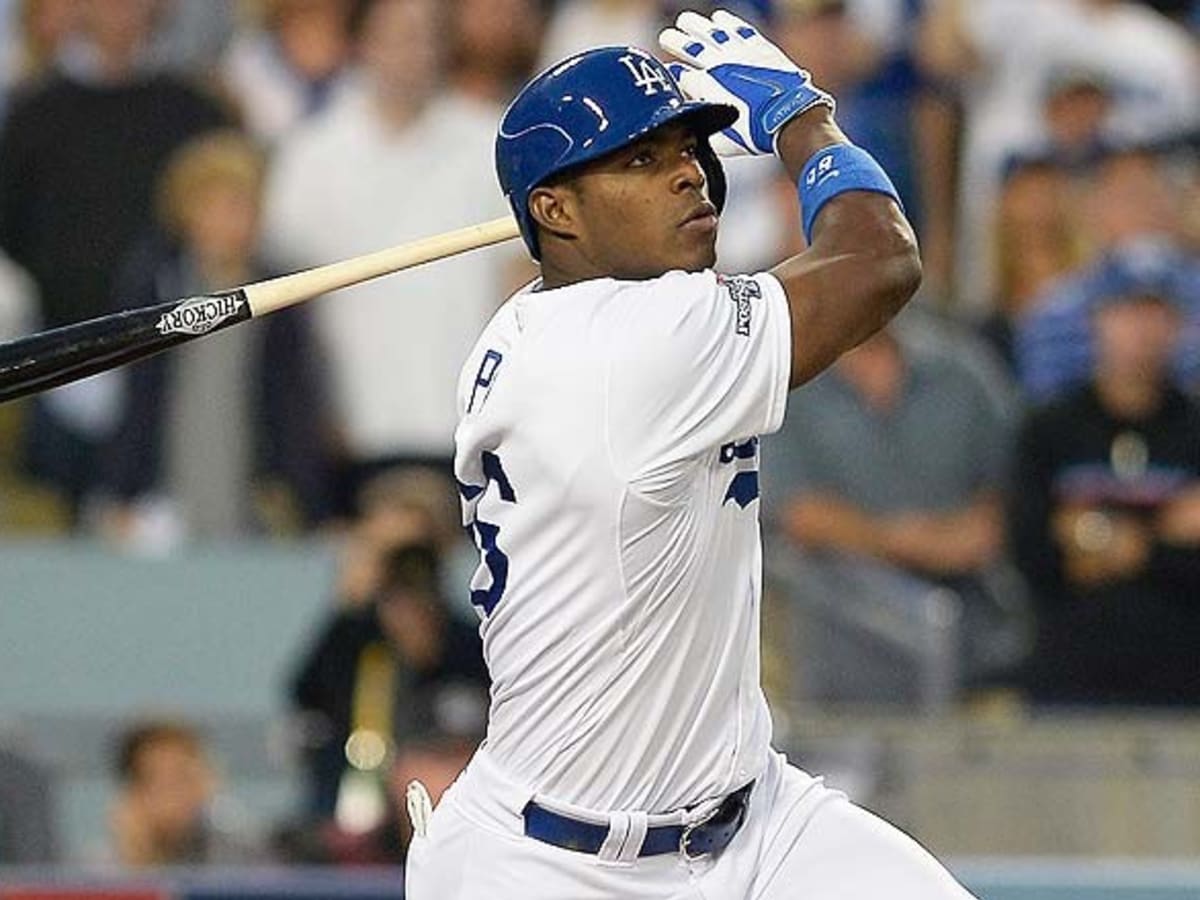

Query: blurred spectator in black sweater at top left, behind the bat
0;0;224;520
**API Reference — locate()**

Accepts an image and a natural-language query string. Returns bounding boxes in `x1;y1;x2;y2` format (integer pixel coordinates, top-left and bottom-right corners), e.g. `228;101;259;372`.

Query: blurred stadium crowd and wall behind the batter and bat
0;0;1200;900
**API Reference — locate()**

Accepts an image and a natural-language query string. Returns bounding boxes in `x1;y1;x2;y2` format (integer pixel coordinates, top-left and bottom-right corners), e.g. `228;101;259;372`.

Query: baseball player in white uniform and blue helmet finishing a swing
407;11;970;900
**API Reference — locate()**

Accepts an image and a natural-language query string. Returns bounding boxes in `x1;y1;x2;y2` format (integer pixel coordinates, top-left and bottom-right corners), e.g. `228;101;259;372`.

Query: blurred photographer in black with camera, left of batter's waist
285;544;487;832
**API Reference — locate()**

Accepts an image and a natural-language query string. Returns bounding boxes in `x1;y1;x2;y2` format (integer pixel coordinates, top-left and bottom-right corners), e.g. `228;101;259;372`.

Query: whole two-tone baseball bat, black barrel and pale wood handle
0;216;518;403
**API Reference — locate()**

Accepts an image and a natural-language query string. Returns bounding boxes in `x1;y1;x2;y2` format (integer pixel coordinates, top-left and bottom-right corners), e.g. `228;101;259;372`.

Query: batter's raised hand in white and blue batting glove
659;10;834;156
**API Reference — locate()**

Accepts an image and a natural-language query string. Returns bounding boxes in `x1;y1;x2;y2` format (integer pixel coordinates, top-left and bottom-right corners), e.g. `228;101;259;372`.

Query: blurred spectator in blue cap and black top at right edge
1010;256;1200;703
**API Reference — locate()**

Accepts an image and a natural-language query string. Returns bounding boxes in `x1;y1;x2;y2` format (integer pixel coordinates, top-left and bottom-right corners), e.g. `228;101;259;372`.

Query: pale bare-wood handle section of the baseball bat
241;216;521;316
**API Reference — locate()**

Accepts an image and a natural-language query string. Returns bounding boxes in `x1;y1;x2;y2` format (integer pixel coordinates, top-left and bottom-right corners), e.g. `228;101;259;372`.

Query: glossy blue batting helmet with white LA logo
496;47;738;259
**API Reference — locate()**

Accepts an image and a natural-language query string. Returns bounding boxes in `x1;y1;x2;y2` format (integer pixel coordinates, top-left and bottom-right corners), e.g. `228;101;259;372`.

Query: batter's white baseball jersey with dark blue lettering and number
455;271;791;811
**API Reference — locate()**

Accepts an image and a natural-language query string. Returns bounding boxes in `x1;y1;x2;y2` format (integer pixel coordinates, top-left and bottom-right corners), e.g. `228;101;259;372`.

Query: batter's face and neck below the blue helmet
572;125;716;278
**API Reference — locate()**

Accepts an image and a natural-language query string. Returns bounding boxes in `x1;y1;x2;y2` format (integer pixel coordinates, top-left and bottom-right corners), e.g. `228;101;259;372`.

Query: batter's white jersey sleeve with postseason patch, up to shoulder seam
606;271;792;489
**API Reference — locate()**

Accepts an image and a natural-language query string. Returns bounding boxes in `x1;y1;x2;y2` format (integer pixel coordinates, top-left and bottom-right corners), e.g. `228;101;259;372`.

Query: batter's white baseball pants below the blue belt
406;750;971;900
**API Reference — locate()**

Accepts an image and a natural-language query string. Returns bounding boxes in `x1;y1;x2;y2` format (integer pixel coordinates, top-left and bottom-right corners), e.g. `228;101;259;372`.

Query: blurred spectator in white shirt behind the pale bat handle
266;0;508;512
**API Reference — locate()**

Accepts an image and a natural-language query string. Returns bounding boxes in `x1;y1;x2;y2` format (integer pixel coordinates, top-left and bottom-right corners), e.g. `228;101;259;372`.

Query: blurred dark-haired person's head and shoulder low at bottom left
109;720;262;869
